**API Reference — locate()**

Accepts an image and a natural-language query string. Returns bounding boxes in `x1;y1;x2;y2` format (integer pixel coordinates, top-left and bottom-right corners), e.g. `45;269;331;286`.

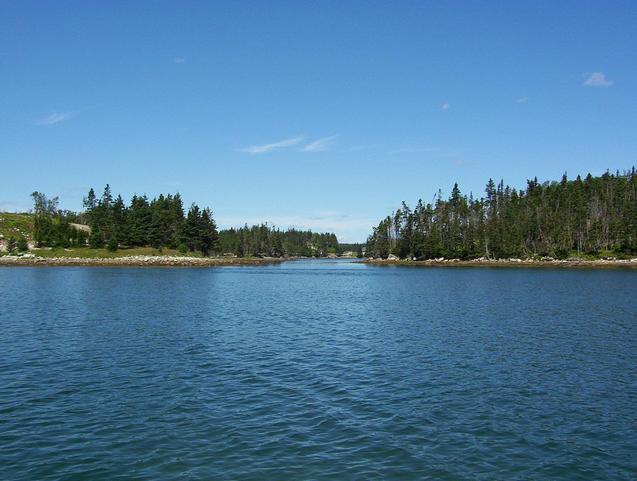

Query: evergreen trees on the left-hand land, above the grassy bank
32;184;339;257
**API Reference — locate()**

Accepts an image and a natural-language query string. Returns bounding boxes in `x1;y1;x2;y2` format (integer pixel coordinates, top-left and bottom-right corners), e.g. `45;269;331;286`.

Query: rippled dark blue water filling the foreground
0;261;637;481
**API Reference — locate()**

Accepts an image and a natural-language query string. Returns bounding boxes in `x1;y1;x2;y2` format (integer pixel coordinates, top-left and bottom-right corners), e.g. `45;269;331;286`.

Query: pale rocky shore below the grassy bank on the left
0;254;286;267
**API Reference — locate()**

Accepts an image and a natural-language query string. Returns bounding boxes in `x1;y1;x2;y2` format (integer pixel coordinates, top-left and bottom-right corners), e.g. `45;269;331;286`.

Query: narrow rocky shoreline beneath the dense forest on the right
361;258;637;269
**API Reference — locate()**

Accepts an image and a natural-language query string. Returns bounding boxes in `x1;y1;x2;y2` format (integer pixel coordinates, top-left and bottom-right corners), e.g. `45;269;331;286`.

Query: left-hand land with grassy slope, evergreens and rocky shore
0;185;363;265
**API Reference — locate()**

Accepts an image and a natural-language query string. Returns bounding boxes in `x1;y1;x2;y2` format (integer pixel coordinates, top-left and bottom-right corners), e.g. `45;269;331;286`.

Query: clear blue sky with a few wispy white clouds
0;0;637;241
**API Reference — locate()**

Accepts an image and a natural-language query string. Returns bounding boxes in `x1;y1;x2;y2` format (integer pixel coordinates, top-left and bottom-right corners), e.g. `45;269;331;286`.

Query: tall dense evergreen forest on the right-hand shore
366;167;637;259
